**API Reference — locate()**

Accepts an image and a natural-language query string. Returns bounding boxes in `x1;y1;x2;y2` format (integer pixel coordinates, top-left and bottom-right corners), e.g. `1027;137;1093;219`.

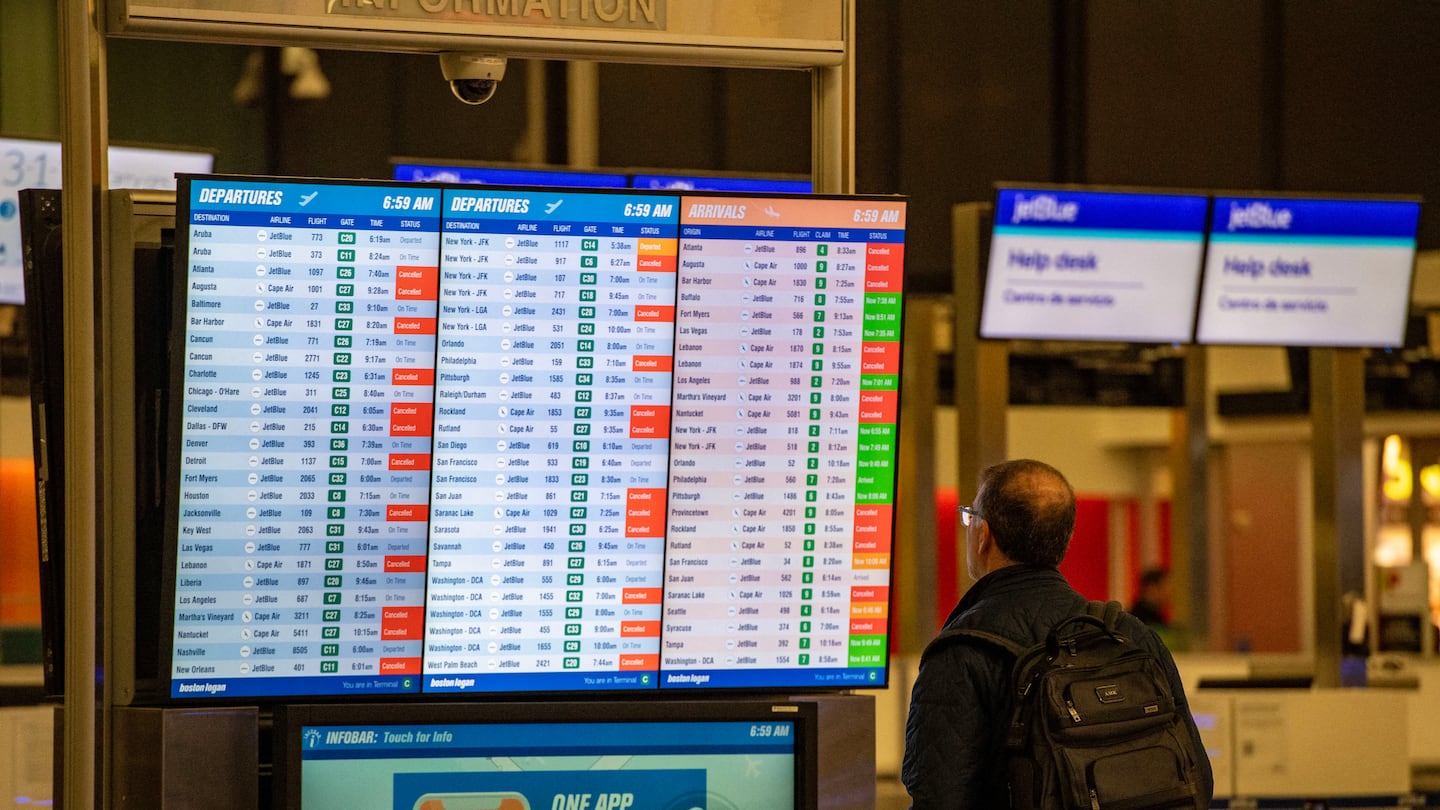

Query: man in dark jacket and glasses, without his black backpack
900;460;1214;810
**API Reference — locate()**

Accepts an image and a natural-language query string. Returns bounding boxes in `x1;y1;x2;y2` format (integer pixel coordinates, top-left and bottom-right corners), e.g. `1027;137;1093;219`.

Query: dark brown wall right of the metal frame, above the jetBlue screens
858;0;1440;291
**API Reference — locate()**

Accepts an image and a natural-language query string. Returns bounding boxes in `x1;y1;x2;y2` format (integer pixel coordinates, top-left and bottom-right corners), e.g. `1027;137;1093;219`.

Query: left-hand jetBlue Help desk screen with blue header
979;187;1208;343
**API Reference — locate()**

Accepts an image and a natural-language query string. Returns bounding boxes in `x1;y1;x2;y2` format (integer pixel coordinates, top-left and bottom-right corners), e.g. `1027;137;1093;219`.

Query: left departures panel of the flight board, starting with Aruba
171;177;439;698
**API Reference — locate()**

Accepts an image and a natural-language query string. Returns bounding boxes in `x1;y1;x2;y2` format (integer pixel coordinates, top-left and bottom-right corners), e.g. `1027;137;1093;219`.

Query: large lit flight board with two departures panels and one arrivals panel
168;176;904;699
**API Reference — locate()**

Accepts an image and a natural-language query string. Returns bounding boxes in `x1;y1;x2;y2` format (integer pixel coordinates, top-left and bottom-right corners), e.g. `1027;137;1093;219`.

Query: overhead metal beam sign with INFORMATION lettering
107;0;848;66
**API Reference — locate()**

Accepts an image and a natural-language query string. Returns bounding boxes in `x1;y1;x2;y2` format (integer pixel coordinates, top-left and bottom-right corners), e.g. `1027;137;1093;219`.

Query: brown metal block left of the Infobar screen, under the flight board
114;706;261;810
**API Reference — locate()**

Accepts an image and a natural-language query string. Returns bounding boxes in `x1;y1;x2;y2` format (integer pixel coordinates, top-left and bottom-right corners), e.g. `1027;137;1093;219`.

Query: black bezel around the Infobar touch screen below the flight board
272;698;819;810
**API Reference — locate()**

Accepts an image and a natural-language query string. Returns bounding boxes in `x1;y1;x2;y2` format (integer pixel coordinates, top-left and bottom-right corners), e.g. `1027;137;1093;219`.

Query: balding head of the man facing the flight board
975;458;1076;568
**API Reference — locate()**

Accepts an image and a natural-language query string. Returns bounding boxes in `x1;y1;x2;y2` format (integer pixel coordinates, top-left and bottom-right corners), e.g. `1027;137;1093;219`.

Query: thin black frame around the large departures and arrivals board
157;174;907;706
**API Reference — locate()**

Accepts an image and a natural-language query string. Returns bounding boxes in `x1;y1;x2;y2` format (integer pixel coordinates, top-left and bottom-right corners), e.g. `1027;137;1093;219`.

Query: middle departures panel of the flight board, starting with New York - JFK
425;189;677;692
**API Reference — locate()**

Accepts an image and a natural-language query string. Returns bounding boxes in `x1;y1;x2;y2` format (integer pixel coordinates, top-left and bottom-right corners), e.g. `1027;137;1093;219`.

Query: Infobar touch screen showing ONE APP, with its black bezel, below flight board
275;702;816;810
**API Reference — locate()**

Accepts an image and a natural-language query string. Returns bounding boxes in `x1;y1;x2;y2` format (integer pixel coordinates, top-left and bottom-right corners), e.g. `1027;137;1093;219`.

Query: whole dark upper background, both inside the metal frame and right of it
92;0;1440;293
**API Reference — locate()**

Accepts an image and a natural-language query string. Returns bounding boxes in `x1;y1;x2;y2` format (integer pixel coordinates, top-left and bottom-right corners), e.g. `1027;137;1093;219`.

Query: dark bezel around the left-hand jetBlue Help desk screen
975;182;1210;344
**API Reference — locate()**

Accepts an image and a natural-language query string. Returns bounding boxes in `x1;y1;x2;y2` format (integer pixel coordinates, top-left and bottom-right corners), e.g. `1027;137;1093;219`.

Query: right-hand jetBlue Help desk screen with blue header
1197;196;1420;347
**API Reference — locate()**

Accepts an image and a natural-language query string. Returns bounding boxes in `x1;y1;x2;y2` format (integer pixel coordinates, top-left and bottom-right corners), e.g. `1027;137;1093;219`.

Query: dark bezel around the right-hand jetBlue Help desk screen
1194;190;1423;349
